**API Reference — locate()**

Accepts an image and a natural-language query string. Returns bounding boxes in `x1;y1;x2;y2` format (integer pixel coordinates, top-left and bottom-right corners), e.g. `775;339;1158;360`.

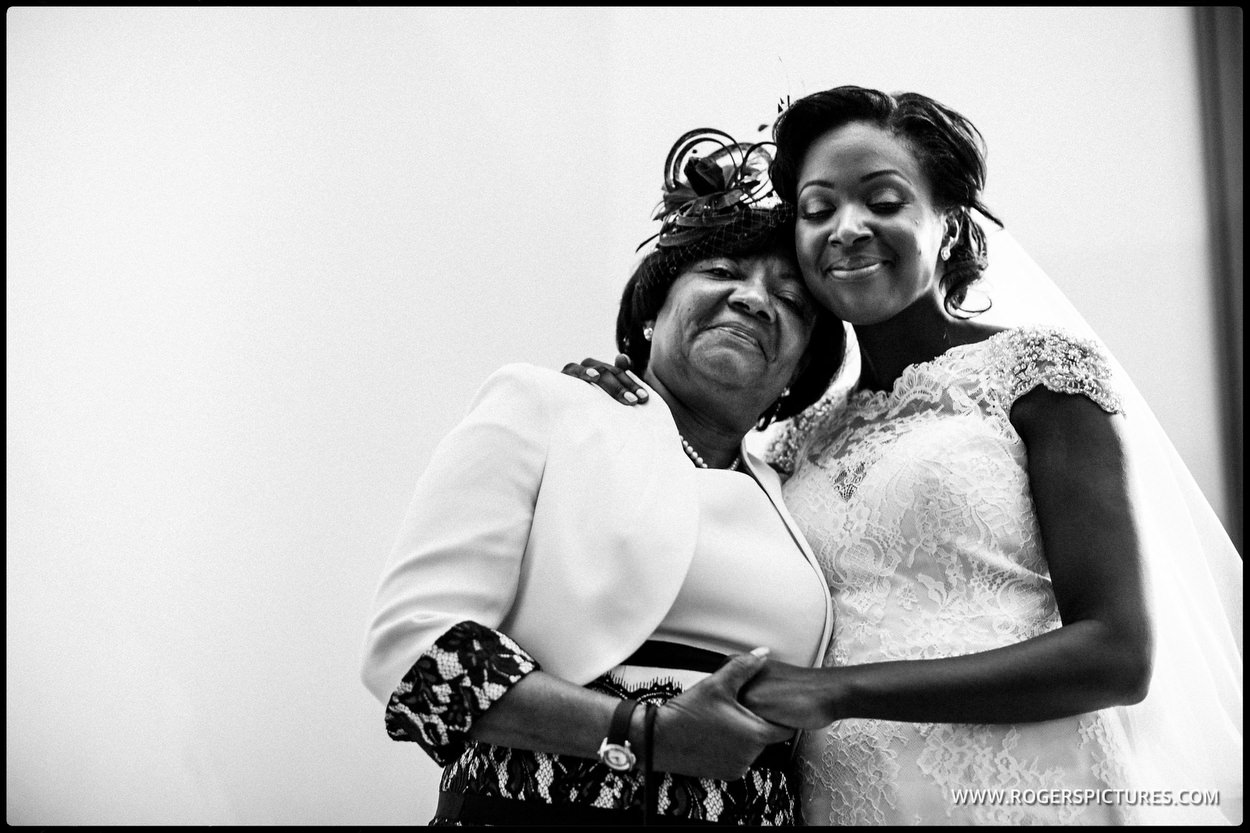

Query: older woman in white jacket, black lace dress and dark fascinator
364;131;843;824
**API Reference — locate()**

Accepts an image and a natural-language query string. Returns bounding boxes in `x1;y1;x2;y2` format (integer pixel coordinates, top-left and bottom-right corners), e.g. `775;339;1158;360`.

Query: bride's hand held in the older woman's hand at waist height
738;660;845;729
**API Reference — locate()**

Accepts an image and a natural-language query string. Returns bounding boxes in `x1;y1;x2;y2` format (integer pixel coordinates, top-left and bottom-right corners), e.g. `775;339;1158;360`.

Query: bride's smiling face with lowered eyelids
795;123;945;324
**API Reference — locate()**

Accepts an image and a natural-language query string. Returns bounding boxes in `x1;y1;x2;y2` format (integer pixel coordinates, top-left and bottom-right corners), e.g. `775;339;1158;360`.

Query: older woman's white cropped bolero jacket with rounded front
363;364;833;703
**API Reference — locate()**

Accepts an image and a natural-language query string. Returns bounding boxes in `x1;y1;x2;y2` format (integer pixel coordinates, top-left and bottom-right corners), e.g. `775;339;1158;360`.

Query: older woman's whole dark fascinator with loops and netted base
639;128;794;284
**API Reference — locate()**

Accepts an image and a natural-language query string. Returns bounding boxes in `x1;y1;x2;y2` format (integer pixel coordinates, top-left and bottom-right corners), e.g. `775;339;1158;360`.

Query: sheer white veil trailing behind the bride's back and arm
968;221;1243;824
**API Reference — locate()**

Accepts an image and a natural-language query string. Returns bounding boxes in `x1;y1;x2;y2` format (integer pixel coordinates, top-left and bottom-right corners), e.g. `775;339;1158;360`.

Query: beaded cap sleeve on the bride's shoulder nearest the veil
1004;326;1124;414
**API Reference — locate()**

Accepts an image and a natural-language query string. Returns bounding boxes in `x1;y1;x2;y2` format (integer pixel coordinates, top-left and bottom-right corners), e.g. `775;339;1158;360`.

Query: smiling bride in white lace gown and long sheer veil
743;86;1241;824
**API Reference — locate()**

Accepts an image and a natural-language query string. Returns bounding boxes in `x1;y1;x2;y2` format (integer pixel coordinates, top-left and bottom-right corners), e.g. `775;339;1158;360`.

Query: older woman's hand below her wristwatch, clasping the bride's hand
654;654;794;780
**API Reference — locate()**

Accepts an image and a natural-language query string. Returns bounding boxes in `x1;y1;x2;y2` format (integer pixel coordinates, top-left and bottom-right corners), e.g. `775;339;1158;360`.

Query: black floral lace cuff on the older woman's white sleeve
386;622;539;767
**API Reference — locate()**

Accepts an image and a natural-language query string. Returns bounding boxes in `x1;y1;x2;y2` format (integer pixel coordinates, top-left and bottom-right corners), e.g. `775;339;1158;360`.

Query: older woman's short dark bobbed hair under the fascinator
616;203;846;428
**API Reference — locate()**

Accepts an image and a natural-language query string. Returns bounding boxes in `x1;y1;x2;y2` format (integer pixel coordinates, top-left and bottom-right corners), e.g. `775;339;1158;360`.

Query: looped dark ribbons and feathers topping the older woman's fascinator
639;128;781;249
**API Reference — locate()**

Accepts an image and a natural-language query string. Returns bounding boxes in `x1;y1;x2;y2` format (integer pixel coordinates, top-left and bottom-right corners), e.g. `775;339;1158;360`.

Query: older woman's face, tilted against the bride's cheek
648;247;816;412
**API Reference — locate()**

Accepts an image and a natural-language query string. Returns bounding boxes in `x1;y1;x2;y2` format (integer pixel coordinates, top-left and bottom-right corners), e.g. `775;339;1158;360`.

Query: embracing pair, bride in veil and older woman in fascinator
363;86;1241;825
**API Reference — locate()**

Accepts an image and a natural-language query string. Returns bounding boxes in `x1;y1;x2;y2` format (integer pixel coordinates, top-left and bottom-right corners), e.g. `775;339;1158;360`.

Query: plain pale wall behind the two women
5;8;1224;824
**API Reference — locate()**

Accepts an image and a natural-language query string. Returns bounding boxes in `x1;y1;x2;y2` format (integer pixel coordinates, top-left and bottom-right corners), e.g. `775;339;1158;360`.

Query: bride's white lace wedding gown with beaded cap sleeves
770;328;1126;824
